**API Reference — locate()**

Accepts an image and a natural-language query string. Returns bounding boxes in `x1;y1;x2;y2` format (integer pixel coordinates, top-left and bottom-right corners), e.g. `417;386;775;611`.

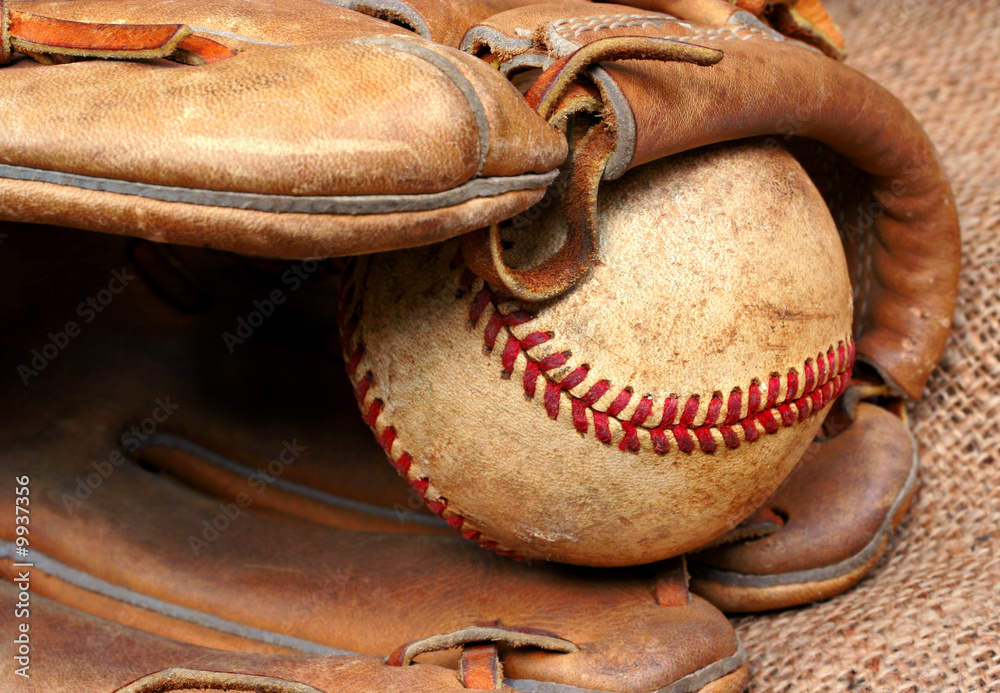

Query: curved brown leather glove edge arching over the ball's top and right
463;3;959;397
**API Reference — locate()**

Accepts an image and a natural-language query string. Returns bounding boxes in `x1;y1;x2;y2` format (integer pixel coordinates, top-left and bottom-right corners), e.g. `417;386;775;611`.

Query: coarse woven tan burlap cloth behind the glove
737;0;1000;693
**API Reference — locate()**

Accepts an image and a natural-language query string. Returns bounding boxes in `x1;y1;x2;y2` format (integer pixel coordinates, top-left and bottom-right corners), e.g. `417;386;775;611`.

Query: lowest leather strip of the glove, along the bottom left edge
0;576;544;693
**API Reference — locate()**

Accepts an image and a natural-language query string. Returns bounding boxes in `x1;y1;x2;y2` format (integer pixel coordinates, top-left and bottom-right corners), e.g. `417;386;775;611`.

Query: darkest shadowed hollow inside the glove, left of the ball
0;224;442;531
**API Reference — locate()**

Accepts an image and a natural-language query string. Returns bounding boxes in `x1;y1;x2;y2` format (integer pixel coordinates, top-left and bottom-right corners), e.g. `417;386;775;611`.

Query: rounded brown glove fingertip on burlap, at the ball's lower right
691;402;917;611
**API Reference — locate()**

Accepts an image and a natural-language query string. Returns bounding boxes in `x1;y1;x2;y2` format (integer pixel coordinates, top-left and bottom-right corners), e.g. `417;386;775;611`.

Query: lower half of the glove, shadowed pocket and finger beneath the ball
0;227;747;693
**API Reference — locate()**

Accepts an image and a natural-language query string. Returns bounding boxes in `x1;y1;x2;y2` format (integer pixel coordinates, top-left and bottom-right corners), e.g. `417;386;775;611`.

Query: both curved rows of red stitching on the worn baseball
340;260;855;558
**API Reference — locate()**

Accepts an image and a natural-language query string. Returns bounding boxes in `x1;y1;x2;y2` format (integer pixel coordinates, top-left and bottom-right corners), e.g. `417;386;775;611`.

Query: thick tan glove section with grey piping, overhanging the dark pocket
0;0;566;257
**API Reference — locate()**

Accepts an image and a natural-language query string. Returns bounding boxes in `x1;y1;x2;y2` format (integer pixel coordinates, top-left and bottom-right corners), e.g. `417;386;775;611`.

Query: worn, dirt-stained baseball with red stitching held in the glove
342;141;854;566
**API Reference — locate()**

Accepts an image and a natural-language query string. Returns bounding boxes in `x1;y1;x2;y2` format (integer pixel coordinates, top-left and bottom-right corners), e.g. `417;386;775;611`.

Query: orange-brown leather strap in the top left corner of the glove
0;0;234;65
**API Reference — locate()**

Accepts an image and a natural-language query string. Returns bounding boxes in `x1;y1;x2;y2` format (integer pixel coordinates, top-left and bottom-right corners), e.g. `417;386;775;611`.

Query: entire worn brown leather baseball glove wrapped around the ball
0;0;958;691
